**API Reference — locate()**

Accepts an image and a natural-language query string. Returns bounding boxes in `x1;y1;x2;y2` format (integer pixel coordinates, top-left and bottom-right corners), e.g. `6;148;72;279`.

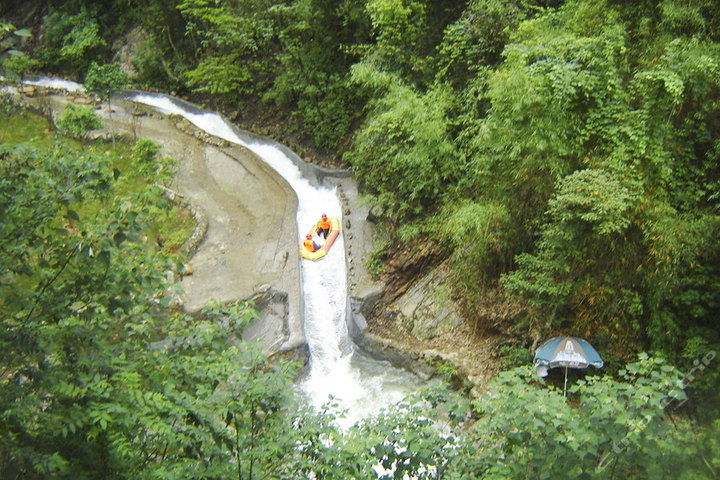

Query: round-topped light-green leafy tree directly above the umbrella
503;169;643;336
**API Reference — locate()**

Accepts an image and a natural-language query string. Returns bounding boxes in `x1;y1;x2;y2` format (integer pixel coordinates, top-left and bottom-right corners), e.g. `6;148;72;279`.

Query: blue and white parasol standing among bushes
533;337;603;395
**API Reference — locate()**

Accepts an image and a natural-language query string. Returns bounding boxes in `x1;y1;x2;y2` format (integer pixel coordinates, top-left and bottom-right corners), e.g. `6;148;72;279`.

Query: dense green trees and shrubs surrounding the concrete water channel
0;0;720;478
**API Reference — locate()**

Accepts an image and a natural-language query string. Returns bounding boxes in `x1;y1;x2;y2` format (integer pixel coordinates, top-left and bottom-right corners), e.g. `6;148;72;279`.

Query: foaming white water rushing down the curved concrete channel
19;78;421;427
